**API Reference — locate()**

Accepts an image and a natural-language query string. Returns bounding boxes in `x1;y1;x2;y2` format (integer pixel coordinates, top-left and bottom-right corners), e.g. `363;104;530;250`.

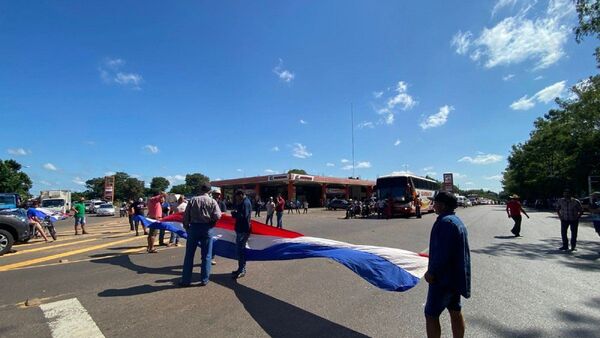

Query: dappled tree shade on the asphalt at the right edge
471;236;600;271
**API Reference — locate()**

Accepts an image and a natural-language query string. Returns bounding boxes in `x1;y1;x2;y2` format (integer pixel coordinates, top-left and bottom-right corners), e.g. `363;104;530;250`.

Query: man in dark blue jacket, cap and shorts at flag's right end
425;191;471;338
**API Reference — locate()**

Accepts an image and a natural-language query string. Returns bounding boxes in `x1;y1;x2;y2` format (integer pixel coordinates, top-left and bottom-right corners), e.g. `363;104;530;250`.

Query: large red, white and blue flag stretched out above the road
136;213;428;291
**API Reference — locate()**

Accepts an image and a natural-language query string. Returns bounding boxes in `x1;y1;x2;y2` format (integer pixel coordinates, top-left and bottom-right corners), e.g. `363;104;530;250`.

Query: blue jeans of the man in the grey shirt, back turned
181;223;213;284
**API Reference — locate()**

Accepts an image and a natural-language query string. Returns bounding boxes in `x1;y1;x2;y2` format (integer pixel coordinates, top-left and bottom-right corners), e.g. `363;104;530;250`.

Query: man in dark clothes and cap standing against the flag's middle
231;190;252;279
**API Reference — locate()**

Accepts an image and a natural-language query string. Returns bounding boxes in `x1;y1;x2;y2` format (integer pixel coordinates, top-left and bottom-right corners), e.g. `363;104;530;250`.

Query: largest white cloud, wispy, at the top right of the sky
452;0;575;70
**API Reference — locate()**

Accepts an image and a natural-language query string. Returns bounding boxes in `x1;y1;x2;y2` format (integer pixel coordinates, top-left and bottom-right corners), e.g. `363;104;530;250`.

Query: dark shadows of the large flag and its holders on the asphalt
93;255;367;337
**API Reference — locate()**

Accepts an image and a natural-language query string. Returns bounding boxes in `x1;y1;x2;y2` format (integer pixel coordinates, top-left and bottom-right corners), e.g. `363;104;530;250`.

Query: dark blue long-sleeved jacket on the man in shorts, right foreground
428;213;471;298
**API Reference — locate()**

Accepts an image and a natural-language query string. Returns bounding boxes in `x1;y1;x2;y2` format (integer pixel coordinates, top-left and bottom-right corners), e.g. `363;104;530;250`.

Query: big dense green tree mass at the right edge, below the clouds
503;75;600;199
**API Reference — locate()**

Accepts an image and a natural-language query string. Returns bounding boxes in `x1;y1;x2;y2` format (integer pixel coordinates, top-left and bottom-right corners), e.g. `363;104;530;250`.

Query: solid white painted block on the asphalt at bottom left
40;298;104;338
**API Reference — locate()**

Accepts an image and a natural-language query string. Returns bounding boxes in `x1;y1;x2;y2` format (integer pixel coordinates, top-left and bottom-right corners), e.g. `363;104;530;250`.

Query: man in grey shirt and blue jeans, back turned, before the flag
179;184;221;287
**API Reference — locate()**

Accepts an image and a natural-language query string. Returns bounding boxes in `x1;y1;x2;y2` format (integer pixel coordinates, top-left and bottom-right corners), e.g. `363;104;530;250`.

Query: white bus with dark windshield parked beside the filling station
376;174;440;217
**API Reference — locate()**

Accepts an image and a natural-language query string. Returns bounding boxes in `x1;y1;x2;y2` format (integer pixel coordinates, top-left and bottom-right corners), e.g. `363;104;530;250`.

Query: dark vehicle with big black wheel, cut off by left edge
0;209;32;256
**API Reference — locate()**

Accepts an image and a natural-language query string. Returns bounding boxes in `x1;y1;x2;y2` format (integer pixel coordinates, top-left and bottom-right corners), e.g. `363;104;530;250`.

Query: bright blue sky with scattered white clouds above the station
0;0;596;193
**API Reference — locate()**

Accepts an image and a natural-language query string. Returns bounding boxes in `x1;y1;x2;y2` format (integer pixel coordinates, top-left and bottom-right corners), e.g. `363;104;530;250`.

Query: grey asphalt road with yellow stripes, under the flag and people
0;206;600;337
